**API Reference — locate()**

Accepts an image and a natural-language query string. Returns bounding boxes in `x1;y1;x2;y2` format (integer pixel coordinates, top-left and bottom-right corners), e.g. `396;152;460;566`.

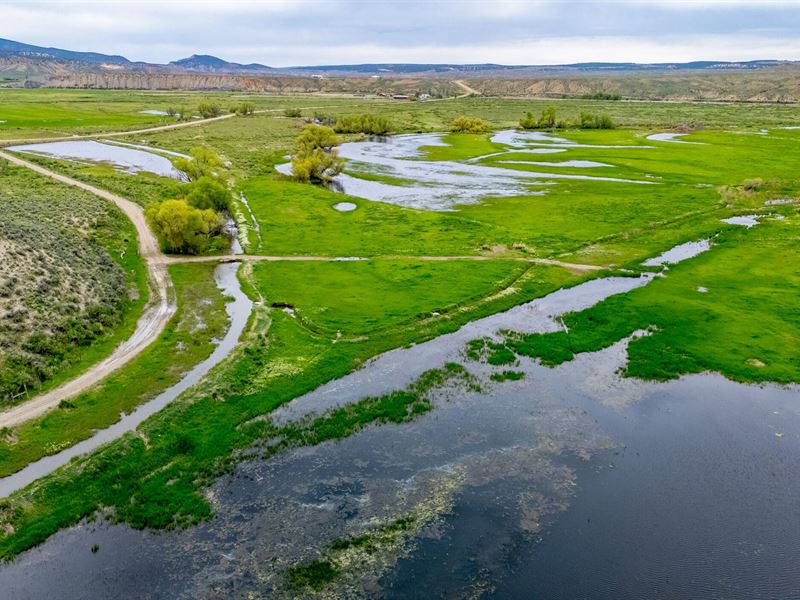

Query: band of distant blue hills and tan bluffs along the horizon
0;39;800;94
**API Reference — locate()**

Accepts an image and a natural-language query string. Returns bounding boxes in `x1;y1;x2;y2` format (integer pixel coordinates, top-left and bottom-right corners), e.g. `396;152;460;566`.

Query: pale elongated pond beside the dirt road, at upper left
8;140;187;181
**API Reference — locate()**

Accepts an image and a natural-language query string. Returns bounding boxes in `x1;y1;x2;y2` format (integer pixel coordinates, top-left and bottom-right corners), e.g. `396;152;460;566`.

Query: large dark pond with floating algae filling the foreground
0;343;800;600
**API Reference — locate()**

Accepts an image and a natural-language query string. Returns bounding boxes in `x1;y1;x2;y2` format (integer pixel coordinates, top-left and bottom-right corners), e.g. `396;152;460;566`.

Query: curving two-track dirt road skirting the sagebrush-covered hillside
0;151;176;427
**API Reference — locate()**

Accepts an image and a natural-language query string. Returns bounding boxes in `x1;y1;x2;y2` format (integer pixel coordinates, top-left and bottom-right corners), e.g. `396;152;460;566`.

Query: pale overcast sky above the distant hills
0;0;800;67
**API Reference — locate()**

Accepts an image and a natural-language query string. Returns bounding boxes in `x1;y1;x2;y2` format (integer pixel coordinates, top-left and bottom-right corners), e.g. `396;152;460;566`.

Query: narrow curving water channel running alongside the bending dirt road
0;263;252;496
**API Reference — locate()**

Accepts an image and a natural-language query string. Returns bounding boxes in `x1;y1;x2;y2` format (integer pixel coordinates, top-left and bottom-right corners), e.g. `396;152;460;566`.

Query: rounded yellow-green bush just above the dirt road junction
146;200;224;254
